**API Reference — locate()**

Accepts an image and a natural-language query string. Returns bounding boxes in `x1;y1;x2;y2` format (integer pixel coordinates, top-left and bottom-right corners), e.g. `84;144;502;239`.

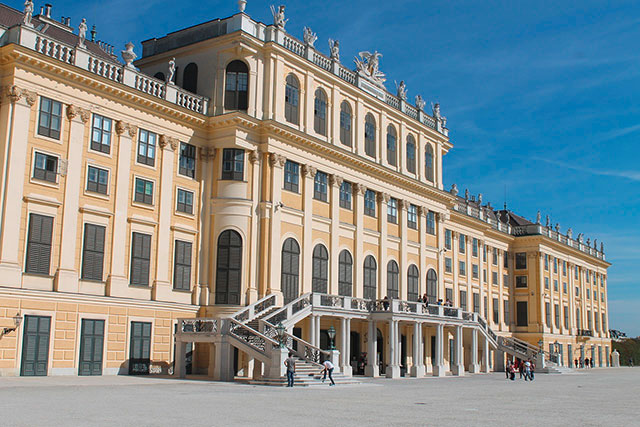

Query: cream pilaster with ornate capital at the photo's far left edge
0;86;37;288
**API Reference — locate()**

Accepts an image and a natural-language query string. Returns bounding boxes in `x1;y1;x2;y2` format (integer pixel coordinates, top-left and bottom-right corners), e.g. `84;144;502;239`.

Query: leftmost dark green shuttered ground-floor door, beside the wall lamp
20;316;51;377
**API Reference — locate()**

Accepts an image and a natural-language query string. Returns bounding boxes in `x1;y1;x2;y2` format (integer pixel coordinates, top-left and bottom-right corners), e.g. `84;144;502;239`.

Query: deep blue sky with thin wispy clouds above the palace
8;0;640;336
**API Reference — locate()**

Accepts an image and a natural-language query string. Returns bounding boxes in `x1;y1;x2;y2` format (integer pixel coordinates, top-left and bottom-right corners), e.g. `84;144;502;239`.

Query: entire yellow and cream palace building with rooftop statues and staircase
0;1;611;381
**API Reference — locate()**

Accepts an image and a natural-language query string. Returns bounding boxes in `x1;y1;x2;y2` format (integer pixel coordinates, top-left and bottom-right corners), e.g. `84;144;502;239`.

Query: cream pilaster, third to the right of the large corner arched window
300;165;318;295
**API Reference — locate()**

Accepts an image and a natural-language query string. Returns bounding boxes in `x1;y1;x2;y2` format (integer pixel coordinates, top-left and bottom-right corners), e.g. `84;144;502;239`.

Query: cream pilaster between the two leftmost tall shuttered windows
54;105;91;293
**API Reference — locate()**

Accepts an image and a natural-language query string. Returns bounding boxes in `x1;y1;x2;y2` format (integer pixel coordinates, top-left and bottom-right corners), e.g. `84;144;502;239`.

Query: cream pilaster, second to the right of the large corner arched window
266;153;287;305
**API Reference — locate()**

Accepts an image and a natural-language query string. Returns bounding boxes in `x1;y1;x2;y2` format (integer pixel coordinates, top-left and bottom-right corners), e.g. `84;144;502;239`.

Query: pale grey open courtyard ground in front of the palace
0;368;640;427
